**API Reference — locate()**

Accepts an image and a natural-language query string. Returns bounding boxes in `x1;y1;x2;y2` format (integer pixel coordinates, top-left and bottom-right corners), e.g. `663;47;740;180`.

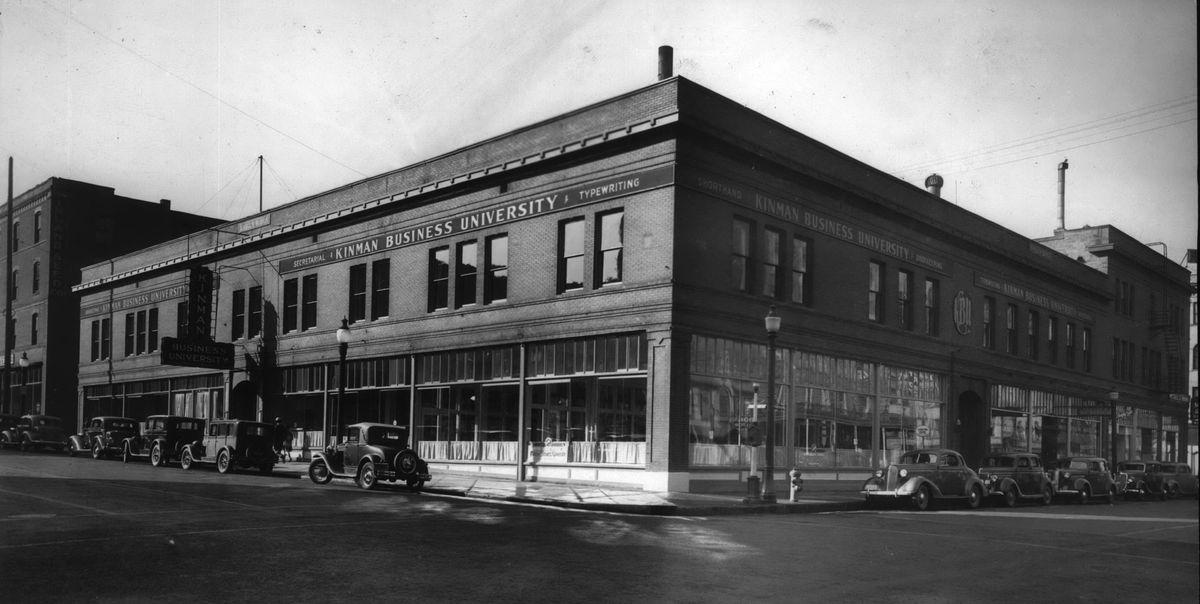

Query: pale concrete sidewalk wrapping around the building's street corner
275;461;864;516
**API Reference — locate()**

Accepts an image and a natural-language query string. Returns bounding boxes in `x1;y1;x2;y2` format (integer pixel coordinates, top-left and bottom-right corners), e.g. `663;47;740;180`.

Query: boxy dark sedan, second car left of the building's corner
179;419;275;474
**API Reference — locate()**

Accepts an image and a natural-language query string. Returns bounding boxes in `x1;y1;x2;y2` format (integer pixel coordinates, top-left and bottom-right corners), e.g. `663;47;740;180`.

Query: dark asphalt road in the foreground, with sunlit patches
0;450;1200;603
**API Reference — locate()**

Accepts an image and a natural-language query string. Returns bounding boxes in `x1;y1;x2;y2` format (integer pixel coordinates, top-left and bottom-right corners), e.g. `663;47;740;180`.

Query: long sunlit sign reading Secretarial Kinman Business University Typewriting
280;166;674;273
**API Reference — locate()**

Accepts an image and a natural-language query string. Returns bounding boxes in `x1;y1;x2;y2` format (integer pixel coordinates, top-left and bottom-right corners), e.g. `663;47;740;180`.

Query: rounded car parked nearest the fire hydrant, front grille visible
862;449;986;510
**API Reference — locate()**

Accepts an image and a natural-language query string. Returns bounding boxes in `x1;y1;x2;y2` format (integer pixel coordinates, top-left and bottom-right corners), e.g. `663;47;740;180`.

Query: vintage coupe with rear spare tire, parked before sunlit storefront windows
308;423;431;489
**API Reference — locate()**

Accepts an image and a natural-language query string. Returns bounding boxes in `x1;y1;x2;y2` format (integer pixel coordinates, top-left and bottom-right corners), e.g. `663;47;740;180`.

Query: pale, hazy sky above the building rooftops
0;0;1198;262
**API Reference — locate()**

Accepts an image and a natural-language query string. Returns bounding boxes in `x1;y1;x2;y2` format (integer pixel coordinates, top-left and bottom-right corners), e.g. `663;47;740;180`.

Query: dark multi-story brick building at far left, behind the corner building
0;178;221;426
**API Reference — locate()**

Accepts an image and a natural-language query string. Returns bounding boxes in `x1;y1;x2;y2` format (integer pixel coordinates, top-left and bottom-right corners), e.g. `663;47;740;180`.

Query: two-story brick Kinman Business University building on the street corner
76;77;1186;491
